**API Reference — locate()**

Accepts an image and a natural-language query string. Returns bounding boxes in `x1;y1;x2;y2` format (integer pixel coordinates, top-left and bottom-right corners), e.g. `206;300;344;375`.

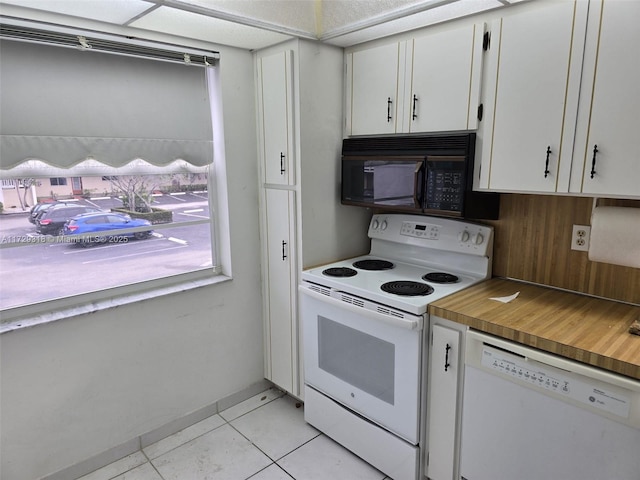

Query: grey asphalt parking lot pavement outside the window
0;192;212;308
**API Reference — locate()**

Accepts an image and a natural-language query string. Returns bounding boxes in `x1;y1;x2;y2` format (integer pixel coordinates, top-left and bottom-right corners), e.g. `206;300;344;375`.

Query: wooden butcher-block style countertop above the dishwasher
429;278;640;380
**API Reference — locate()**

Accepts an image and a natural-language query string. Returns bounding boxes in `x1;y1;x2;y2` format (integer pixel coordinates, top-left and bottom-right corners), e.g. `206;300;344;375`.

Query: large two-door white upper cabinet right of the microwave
479;0;640;197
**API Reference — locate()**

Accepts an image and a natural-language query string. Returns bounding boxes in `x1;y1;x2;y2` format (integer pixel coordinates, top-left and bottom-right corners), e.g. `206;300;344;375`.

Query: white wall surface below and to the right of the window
0;43;263;480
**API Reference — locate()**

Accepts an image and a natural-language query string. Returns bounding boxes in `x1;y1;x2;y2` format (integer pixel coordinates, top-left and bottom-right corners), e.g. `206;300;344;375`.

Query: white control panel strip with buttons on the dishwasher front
481;345;631;418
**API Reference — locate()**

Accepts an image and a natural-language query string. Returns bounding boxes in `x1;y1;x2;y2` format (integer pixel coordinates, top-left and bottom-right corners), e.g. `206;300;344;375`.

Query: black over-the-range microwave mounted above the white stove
341;132;500;220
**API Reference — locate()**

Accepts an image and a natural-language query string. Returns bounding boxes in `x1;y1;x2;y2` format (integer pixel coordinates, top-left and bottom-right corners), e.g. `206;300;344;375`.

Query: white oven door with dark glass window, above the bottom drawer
300;283;424;445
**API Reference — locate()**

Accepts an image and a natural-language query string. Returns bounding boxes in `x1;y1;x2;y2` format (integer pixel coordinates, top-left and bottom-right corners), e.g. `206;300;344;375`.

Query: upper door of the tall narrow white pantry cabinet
258;51;295;185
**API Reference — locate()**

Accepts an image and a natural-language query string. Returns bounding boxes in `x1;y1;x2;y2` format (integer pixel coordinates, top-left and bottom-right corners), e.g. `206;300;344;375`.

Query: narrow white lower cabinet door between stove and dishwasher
427;325;461;480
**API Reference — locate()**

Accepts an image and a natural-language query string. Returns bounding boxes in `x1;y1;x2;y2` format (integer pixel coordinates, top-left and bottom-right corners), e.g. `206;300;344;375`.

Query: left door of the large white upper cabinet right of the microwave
482;1;587;192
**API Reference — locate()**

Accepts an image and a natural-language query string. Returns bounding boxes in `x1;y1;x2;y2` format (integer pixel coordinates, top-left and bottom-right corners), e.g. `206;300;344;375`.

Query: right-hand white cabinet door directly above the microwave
405;25;482;132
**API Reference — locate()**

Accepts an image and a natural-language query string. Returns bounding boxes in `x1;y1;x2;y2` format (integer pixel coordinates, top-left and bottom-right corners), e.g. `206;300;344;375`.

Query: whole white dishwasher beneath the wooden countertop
460;331;640;480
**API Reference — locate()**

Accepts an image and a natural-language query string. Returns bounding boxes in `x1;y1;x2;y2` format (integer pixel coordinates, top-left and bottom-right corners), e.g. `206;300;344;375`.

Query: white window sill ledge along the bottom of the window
0;275;231;335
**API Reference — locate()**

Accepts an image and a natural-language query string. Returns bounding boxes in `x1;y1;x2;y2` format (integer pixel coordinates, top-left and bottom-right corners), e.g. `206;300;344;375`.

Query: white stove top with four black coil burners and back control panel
302;214;493;315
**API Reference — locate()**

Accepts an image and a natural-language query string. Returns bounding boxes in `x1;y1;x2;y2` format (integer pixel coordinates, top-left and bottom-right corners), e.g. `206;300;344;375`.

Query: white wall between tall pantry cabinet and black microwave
296;40;371;268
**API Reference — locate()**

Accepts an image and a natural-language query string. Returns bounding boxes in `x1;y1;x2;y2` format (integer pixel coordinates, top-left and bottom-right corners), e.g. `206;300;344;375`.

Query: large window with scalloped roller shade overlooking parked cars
0;23;226;320
